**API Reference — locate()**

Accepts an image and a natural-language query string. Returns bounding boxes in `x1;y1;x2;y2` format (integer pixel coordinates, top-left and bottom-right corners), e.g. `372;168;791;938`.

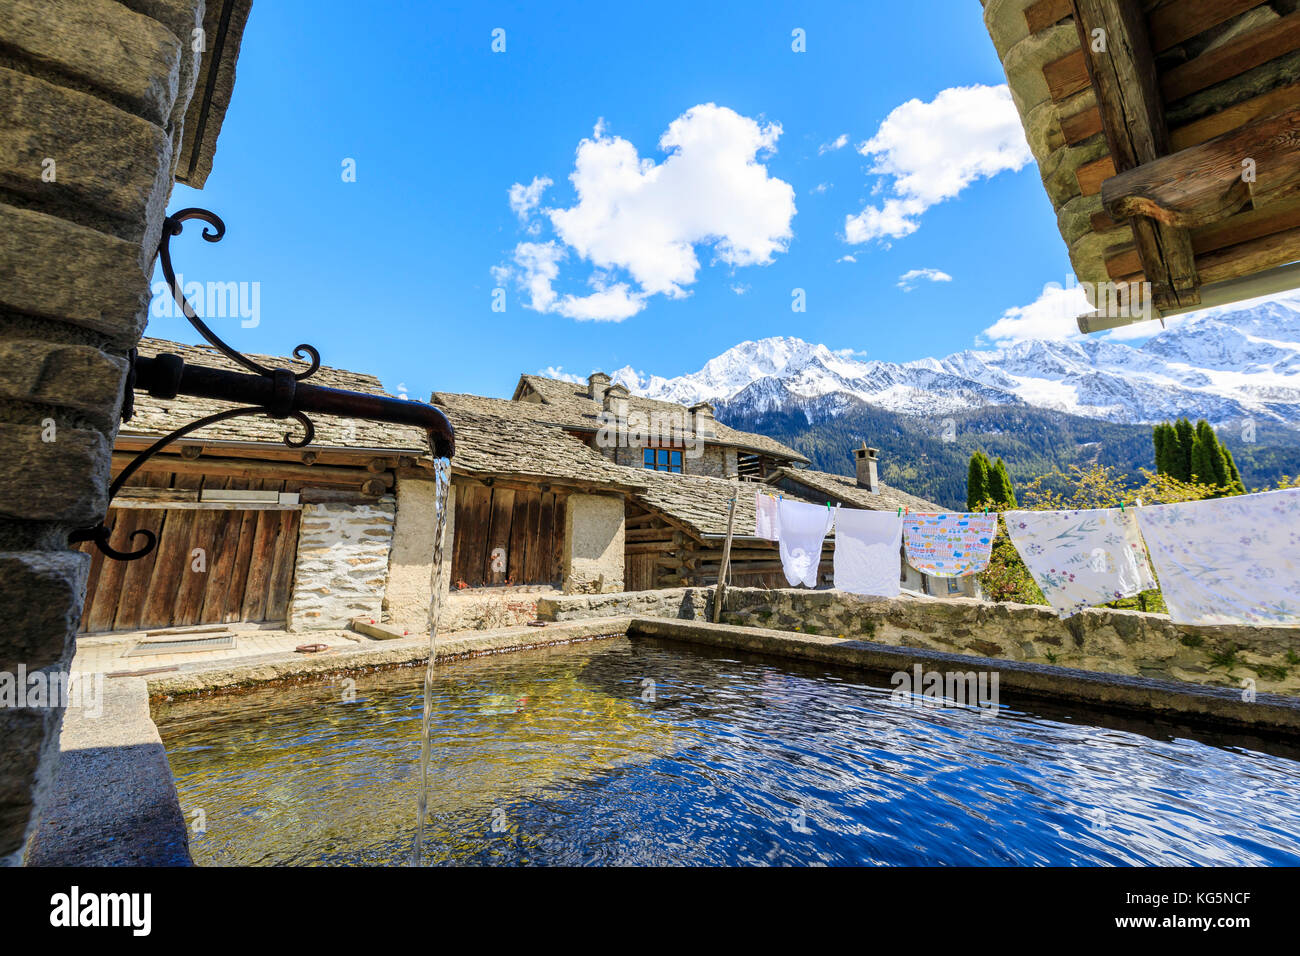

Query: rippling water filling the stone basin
157;639;1300;865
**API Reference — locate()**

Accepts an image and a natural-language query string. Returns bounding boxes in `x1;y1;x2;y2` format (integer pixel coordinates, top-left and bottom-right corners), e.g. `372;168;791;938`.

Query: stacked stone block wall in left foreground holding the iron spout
0;0;204;862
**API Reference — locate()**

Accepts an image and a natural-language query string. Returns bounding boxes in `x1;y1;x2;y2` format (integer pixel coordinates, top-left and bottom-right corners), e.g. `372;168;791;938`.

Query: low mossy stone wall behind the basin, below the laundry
537;588;1300;695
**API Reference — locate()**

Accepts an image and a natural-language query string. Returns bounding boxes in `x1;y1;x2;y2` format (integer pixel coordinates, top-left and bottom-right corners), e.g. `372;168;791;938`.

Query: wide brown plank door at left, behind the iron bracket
81;472;303;632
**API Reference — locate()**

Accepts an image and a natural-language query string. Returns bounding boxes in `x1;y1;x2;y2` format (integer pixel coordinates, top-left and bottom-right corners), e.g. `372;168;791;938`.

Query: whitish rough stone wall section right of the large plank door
289;497;397;631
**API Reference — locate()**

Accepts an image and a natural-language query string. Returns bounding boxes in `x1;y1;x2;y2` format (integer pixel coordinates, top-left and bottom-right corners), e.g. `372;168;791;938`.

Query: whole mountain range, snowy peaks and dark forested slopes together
611;299;1300;507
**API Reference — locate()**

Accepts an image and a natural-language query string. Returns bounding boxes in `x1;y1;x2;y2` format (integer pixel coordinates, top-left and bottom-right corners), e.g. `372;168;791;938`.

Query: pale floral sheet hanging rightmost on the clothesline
1138;488;1300;627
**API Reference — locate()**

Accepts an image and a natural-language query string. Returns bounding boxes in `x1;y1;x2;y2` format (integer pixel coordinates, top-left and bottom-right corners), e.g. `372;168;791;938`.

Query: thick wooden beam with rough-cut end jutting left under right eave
1101;105;1300;229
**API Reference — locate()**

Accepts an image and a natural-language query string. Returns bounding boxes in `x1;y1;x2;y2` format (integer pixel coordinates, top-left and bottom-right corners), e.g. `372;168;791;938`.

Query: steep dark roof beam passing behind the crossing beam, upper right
1071;0;1200;310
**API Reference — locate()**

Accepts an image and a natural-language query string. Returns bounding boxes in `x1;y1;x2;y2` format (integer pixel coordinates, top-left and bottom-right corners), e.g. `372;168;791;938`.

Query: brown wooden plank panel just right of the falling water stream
451;481;564;588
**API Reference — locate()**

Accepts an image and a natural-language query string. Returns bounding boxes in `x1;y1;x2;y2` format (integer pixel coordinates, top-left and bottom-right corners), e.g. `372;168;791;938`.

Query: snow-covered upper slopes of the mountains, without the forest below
612;299;1300;425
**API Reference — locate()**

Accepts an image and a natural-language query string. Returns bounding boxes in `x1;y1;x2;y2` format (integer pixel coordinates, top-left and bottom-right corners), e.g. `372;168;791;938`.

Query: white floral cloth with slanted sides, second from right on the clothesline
1004;507;1157;618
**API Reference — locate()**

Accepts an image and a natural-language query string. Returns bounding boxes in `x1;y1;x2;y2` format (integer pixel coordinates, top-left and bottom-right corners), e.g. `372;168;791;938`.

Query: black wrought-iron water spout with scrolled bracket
69;207;455;561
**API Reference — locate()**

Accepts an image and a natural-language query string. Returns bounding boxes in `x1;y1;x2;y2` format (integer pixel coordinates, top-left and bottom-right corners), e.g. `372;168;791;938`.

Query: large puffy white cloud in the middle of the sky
494;103;796;321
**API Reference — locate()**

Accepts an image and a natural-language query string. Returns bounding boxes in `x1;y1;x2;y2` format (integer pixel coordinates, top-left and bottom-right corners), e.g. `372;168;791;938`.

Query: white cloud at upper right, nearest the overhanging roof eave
844;85;1034;243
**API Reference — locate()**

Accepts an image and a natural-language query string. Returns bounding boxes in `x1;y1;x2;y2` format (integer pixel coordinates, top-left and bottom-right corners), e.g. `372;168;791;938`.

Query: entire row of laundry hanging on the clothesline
754;488;1300;626
